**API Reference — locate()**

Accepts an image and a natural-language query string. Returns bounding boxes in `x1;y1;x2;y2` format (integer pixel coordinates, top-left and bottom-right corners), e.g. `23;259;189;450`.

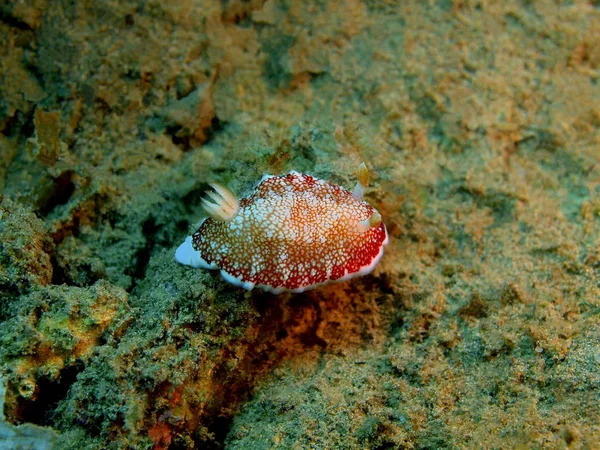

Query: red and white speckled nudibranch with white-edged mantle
175;163;389;294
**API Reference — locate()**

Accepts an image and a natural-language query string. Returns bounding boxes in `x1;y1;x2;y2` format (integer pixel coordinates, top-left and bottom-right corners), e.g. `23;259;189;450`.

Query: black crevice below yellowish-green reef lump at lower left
16;363;83;426
